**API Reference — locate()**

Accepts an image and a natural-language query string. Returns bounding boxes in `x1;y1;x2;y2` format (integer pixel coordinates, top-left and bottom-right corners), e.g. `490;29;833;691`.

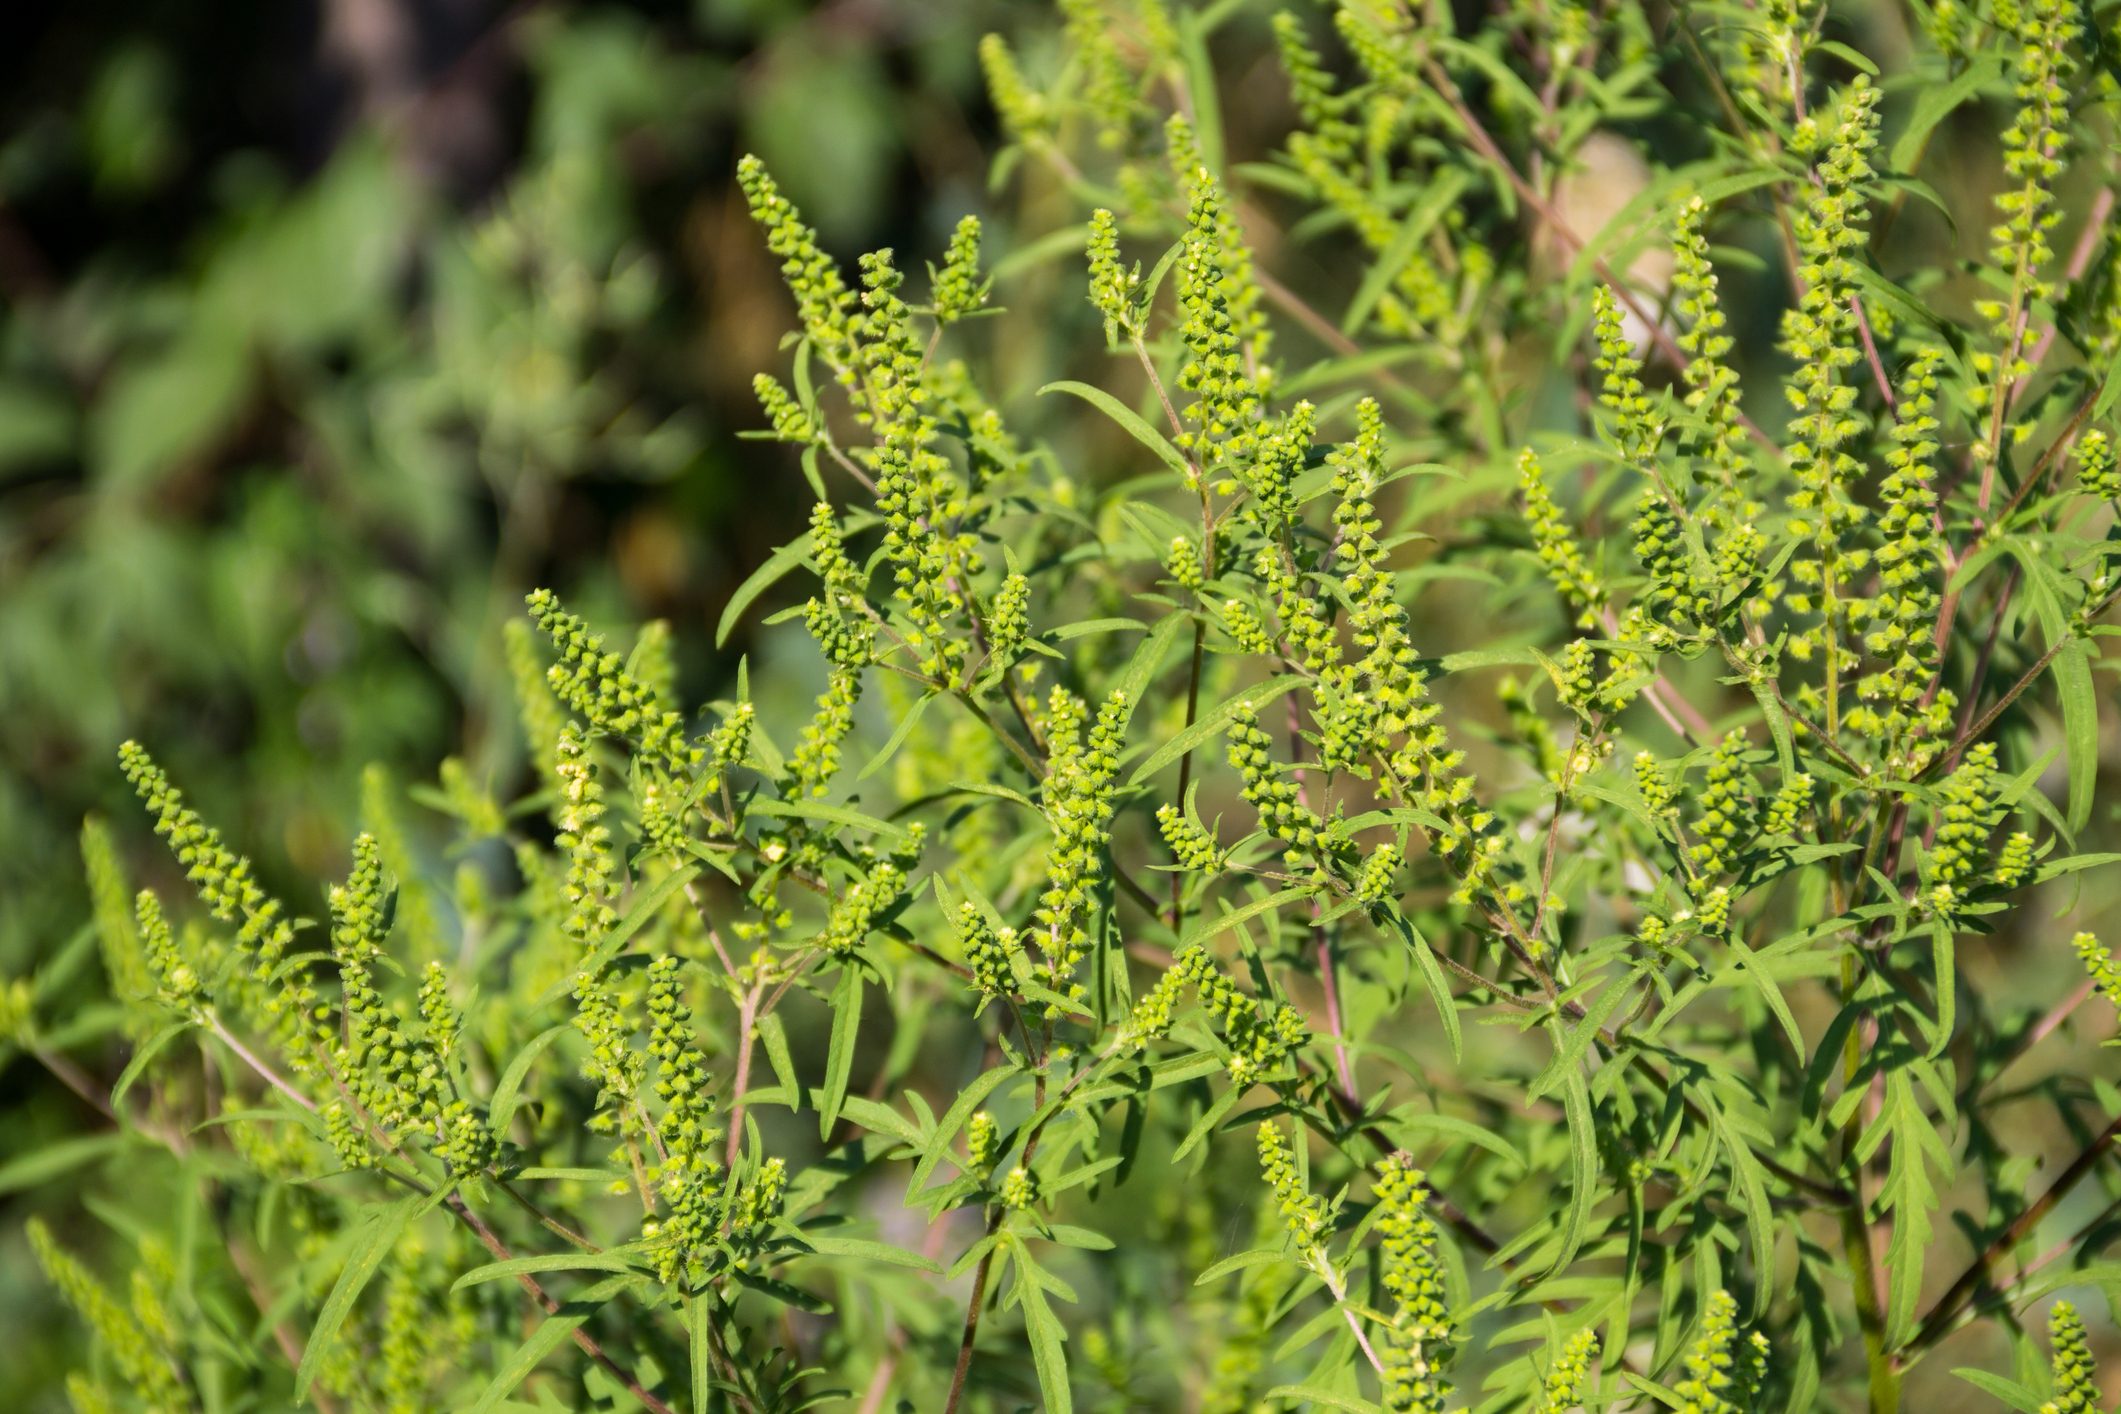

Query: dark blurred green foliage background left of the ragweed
0;0;1035;1410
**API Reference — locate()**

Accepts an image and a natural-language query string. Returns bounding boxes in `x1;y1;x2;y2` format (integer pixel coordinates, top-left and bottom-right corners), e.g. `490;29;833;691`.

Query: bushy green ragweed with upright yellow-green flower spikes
11;0;2121;1414
